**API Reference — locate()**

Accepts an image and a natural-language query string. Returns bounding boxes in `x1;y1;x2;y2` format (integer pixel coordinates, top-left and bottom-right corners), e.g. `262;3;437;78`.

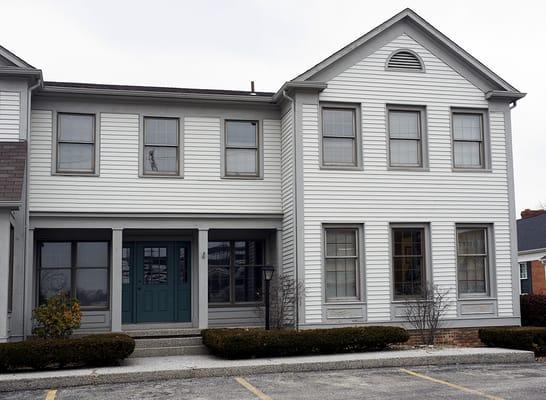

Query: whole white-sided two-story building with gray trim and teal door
0;9;524;340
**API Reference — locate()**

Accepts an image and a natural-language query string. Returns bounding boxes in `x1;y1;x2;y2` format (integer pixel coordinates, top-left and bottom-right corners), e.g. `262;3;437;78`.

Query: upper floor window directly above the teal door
143;117;180;175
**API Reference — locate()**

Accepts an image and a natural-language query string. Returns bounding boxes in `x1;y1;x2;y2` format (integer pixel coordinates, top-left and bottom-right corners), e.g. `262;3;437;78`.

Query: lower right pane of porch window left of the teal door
76;268;108;307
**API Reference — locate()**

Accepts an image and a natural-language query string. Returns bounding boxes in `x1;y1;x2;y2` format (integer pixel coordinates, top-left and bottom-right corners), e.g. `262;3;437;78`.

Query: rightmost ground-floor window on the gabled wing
457;226;489;296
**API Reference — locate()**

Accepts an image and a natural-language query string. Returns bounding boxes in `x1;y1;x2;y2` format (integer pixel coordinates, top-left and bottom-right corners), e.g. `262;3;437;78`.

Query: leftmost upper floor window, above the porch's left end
57;113;96;174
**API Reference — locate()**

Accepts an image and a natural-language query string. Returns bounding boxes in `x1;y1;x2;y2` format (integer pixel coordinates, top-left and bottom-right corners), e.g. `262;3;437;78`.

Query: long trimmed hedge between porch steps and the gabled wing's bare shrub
201;326;409;359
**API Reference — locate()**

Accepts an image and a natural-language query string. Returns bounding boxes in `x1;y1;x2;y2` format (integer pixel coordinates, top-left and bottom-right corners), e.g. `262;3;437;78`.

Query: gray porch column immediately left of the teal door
110;228;123;332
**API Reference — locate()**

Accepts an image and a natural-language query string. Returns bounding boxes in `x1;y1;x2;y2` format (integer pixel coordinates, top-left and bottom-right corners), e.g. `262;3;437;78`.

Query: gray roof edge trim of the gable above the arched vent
292;8;525;99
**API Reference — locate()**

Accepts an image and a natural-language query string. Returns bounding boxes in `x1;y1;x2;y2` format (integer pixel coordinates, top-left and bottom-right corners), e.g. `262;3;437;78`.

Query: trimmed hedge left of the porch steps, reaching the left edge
0;333;135;371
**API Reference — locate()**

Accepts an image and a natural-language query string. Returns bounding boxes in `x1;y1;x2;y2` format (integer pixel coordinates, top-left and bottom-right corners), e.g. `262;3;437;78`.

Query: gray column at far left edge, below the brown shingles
0;210;10;343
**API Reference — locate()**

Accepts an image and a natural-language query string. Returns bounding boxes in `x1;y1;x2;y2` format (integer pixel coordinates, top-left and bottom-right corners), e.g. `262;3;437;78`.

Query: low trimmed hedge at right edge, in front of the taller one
479;327;546;357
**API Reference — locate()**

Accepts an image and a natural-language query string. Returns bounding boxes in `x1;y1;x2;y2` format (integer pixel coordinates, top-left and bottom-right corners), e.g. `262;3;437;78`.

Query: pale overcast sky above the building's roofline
0;0;546;215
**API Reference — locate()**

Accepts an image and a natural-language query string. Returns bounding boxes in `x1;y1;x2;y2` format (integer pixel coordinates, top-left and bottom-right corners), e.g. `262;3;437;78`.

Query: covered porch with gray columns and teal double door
25;215;282;335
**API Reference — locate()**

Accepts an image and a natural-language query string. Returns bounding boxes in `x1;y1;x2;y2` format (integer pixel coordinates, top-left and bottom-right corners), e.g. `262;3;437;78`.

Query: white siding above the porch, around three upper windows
29;111;281;213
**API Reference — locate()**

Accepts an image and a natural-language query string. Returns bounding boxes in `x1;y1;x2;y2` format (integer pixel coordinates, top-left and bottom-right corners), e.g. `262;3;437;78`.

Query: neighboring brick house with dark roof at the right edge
517;209;546;294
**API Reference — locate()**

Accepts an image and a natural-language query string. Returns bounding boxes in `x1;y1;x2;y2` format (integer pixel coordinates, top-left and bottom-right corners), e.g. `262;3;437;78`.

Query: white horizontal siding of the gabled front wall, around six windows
303;35;515;324
